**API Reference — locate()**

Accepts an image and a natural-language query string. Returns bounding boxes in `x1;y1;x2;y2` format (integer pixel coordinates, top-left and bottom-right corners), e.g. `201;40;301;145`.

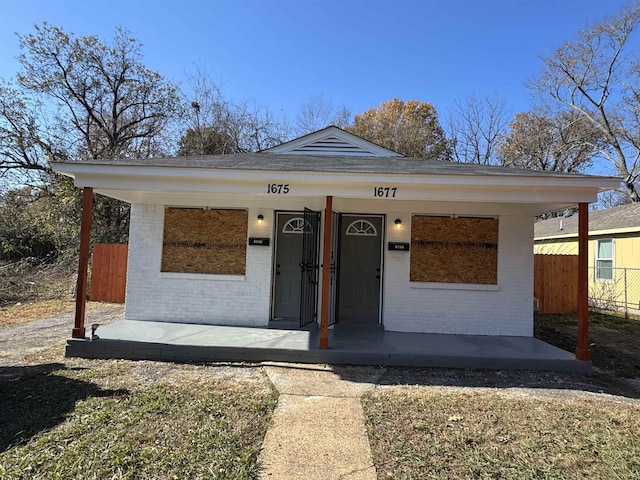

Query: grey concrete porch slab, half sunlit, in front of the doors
66;320;591;373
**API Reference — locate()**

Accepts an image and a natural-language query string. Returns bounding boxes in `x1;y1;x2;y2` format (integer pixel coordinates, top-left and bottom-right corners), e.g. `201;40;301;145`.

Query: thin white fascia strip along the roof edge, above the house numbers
53;163;620;191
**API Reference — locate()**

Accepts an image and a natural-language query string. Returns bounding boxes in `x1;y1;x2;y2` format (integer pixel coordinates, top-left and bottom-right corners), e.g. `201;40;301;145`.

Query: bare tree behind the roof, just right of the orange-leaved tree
449;95;508;165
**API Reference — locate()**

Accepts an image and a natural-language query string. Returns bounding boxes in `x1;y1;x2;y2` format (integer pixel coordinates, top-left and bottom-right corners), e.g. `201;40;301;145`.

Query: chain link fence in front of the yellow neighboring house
589;266;640;315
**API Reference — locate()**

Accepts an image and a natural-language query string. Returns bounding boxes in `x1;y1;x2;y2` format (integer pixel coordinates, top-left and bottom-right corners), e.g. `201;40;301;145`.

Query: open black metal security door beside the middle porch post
300;208;320;327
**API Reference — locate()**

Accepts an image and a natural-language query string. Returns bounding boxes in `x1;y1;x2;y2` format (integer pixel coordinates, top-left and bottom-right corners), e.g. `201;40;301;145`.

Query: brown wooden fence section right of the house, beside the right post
533;255;578;313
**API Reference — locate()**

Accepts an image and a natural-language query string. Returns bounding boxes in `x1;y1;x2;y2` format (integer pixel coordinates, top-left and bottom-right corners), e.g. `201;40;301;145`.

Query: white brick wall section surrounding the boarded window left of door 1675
125;204;273;326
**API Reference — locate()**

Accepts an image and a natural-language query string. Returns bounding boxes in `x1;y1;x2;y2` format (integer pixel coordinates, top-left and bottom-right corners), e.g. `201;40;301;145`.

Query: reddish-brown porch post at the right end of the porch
576;203;591;360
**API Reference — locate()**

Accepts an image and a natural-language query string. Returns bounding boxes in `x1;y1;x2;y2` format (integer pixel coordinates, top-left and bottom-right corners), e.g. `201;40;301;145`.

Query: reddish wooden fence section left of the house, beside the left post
89;243;129;303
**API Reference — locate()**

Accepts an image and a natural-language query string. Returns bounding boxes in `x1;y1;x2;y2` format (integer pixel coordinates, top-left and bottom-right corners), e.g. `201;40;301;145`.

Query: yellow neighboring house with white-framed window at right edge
534;203;640;309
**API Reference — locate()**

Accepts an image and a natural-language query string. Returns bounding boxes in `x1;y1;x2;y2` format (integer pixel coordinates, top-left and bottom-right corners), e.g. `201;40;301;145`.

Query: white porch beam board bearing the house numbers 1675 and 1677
55;172;598;206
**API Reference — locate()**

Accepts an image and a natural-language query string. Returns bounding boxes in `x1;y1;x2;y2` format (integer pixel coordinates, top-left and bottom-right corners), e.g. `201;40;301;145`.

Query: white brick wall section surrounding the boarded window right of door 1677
383;216;533;336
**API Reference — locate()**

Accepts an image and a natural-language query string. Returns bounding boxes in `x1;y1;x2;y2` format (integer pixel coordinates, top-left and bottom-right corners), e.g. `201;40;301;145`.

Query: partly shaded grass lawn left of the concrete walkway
0;360;277;479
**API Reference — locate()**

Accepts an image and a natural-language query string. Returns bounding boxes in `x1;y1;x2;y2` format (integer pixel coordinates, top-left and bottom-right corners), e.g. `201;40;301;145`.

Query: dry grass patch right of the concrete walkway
362;387;640;480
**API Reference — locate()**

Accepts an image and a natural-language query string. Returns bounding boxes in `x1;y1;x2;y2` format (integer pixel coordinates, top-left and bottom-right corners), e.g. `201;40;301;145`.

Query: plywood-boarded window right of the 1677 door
409;215;498;285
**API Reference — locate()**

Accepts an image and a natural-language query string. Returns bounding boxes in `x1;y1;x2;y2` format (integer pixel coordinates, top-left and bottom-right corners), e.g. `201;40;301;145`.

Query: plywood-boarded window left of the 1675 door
162;208;247;275
